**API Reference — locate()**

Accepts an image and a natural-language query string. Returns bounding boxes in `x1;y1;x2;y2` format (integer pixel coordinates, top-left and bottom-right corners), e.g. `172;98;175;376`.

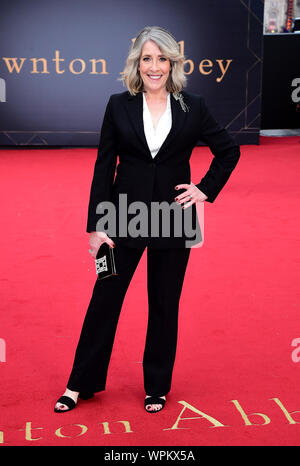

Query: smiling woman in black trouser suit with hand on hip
55;26;240;413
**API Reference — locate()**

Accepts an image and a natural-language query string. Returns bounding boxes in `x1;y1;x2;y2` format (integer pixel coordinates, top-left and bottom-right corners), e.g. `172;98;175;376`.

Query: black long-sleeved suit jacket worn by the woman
87;91;240;248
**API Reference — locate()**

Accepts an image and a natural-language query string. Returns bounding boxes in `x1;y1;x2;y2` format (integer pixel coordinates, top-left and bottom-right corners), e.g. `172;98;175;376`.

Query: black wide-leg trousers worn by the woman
67;246;190;396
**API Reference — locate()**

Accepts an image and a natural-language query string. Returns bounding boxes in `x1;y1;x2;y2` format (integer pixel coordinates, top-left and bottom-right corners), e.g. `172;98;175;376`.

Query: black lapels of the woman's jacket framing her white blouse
126;92;186;164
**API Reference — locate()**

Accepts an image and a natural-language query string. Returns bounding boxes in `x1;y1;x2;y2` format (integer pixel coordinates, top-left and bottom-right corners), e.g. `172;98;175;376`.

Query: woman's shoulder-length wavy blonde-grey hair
119;26;187;95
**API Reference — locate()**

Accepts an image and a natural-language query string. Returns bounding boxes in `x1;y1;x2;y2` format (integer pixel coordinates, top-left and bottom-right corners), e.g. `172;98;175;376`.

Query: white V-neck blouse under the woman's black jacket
143;92;172;158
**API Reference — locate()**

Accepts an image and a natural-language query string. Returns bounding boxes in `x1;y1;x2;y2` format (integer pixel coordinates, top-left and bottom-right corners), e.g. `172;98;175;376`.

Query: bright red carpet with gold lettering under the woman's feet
0;137;300;446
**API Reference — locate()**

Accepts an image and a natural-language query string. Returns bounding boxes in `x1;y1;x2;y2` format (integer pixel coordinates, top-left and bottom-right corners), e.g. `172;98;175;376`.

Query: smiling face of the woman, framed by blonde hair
139;40;170;92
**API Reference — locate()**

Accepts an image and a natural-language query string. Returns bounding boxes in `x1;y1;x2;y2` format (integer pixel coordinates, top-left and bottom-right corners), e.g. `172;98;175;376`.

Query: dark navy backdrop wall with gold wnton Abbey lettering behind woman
0;0;263;146
